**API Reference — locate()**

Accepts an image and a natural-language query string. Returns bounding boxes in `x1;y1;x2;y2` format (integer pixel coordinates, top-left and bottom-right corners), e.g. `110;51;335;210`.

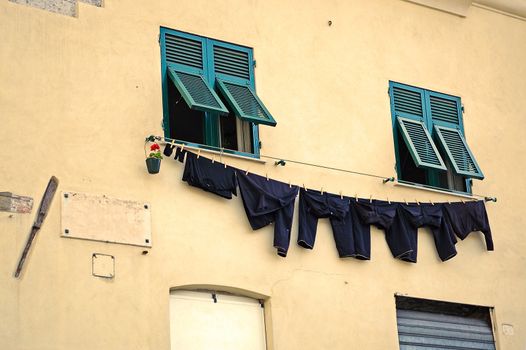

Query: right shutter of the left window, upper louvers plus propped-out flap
213;42;276;126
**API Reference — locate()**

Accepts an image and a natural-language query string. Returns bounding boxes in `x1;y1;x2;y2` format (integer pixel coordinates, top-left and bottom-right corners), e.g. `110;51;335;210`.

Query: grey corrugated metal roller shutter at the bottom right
396;309;495;350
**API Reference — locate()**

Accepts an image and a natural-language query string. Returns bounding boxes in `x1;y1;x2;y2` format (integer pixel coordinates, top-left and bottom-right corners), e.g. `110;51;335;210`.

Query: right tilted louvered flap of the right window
435;125;484;180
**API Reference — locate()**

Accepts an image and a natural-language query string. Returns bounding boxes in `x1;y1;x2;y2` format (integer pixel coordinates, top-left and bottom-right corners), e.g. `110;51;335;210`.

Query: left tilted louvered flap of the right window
396;117;447;170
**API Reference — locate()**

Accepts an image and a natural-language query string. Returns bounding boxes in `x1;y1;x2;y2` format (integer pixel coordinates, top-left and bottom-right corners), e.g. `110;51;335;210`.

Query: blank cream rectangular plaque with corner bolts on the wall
61;192;152;247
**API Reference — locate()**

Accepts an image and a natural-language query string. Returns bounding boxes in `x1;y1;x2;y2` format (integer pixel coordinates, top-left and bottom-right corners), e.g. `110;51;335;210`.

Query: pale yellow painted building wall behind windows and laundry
0;0;526;350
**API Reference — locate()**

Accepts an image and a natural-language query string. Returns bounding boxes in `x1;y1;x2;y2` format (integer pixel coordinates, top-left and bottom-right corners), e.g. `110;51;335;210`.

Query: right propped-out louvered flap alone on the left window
217;79;276;126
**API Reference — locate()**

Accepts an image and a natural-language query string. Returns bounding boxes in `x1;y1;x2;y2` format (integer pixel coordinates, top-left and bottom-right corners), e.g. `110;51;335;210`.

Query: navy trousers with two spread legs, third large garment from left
298;189;371;260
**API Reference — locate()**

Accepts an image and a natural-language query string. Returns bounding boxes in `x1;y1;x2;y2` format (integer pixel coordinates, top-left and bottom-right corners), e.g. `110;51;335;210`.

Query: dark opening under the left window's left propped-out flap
168;81;205;144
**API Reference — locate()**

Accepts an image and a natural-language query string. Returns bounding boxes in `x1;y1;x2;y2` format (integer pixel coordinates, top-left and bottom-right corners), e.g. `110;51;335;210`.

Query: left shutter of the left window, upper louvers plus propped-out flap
163;32;228;114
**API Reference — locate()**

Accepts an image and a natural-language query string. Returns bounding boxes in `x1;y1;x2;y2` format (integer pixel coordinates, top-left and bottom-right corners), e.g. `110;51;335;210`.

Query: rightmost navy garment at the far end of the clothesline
444;201;494;250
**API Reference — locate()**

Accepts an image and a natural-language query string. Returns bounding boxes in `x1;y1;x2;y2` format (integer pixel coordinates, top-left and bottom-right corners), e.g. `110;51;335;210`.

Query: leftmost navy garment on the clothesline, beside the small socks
183;151;237;199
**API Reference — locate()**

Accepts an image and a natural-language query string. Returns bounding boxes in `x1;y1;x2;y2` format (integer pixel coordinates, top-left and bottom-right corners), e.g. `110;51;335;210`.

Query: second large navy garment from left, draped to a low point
237;170;298;257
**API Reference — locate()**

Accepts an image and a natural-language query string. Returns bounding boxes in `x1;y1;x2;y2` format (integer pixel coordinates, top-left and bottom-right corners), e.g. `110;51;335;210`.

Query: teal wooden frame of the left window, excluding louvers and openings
159;26;260;159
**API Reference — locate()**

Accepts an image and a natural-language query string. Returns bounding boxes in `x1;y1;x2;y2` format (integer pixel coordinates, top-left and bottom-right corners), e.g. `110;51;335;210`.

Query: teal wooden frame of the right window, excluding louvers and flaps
389;80;472;195
